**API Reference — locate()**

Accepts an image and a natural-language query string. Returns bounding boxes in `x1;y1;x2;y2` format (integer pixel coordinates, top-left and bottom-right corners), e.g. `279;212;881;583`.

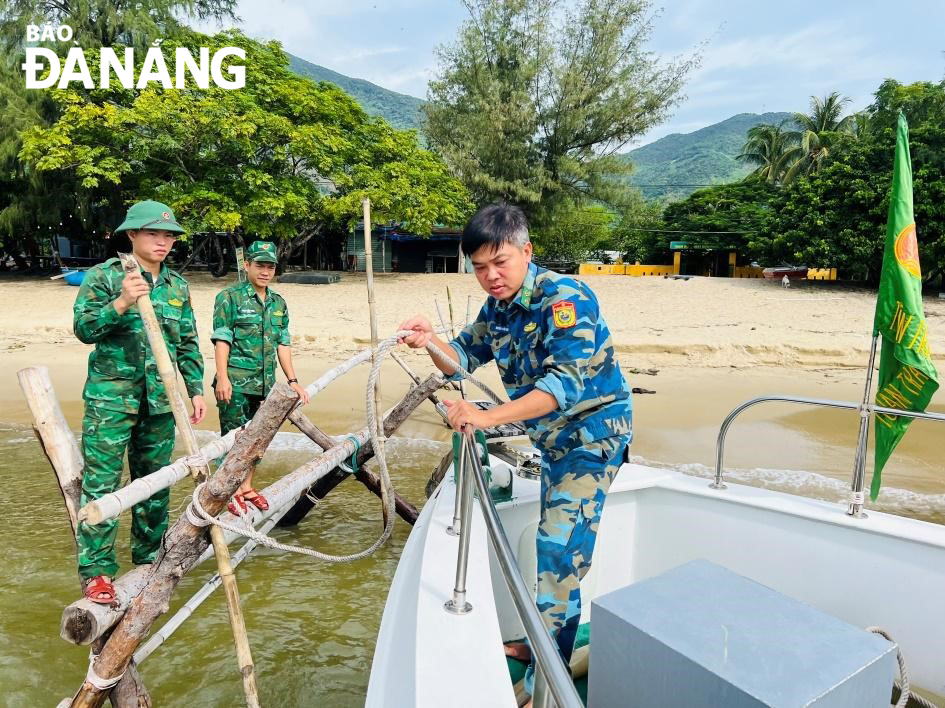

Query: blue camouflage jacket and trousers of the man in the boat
450;263;632;691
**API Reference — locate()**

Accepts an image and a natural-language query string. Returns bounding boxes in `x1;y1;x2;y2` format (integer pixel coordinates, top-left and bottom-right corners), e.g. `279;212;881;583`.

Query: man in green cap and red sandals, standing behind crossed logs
210;241;308;514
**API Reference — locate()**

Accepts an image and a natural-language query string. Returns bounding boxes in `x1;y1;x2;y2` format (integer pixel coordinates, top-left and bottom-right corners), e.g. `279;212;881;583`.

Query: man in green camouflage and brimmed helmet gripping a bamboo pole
73;201;206;603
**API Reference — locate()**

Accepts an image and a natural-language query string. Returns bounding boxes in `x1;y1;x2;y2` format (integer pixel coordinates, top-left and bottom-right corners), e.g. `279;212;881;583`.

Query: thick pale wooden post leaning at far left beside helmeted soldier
17;366;151;708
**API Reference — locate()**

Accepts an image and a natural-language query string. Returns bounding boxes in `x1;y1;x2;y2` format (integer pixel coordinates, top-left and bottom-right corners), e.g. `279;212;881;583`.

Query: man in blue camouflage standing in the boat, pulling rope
400;204;632;692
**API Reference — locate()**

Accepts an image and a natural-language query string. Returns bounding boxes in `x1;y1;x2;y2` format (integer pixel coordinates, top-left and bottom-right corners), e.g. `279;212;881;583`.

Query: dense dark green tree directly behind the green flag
757;80;945;282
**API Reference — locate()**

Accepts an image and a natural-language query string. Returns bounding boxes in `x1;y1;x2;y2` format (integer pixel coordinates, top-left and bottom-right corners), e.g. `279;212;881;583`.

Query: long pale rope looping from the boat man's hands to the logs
179;330;502;564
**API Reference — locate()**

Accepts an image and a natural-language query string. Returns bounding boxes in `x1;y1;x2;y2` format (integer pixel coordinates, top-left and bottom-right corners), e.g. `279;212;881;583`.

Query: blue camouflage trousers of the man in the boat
525;435;629;693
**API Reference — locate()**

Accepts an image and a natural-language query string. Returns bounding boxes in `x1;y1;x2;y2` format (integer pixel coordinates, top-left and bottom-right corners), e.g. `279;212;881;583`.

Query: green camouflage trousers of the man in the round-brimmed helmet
76;401;174;578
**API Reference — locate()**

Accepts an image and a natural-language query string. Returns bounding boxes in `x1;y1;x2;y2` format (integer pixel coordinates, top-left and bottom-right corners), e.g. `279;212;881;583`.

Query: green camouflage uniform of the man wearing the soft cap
210;282;291;435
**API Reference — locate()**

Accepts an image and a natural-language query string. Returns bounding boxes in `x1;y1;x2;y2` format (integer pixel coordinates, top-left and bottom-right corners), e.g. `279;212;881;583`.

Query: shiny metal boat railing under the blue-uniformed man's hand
445;431;584;708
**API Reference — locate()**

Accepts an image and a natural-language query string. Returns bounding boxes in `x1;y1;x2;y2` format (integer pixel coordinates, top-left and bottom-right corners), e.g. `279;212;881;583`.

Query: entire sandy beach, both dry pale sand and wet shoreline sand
0;274;945;494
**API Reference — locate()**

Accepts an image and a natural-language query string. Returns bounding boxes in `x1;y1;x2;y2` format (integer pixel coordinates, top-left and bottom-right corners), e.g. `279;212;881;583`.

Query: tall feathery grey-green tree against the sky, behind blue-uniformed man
424;0;694;226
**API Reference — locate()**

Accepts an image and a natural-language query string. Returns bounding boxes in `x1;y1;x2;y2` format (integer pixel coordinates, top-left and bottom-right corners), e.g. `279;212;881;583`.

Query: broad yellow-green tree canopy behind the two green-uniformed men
15;31;467;258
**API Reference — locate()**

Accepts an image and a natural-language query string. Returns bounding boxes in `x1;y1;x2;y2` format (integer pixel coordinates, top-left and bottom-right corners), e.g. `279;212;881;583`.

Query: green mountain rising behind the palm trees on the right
623;113;791;200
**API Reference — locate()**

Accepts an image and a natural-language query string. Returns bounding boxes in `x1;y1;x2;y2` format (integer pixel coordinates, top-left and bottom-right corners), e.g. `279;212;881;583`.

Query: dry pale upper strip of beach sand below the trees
0;274;945;401
